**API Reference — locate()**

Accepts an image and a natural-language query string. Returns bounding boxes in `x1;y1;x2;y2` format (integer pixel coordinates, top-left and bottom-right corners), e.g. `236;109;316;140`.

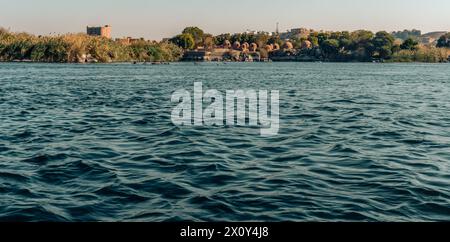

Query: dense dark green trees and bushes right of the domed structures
296;30;450;63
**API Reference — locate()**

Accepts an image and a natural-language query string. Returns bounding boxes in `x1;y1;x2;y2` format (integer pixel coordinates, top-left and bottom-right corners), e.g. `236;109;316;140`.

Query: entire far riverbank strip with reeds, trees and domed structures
0;28;450;63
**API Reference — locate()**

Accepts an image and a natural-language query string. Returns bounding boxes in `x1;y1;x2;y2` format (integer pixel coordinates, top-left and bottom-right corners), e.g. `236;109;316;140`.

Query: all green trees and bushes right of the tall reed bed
170;27;450;61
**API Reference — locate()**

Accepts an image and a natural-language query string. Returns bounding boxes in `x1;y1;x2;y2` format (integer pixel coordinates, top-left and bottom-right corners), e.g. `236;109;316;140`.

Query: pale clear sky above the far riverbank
0;0;450;40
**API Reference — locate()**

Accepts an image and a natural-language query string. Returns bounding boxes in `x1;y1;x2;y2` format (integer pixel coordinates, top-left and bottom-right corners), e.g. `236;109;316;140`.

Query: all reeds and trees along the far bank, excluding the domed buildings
0;27;450;63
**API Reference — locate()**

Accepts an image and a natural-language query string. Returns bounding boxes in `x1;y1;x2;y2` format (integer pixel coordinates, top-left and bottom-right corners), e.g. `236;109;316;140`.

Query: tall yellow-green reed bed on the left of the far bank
0;29;183;62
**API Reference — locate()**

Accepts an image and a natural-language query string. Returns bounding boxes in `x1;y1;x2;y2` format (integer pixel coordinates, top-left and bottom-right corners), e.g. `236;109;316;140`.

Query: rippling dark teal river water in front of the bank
0;63;450;221
